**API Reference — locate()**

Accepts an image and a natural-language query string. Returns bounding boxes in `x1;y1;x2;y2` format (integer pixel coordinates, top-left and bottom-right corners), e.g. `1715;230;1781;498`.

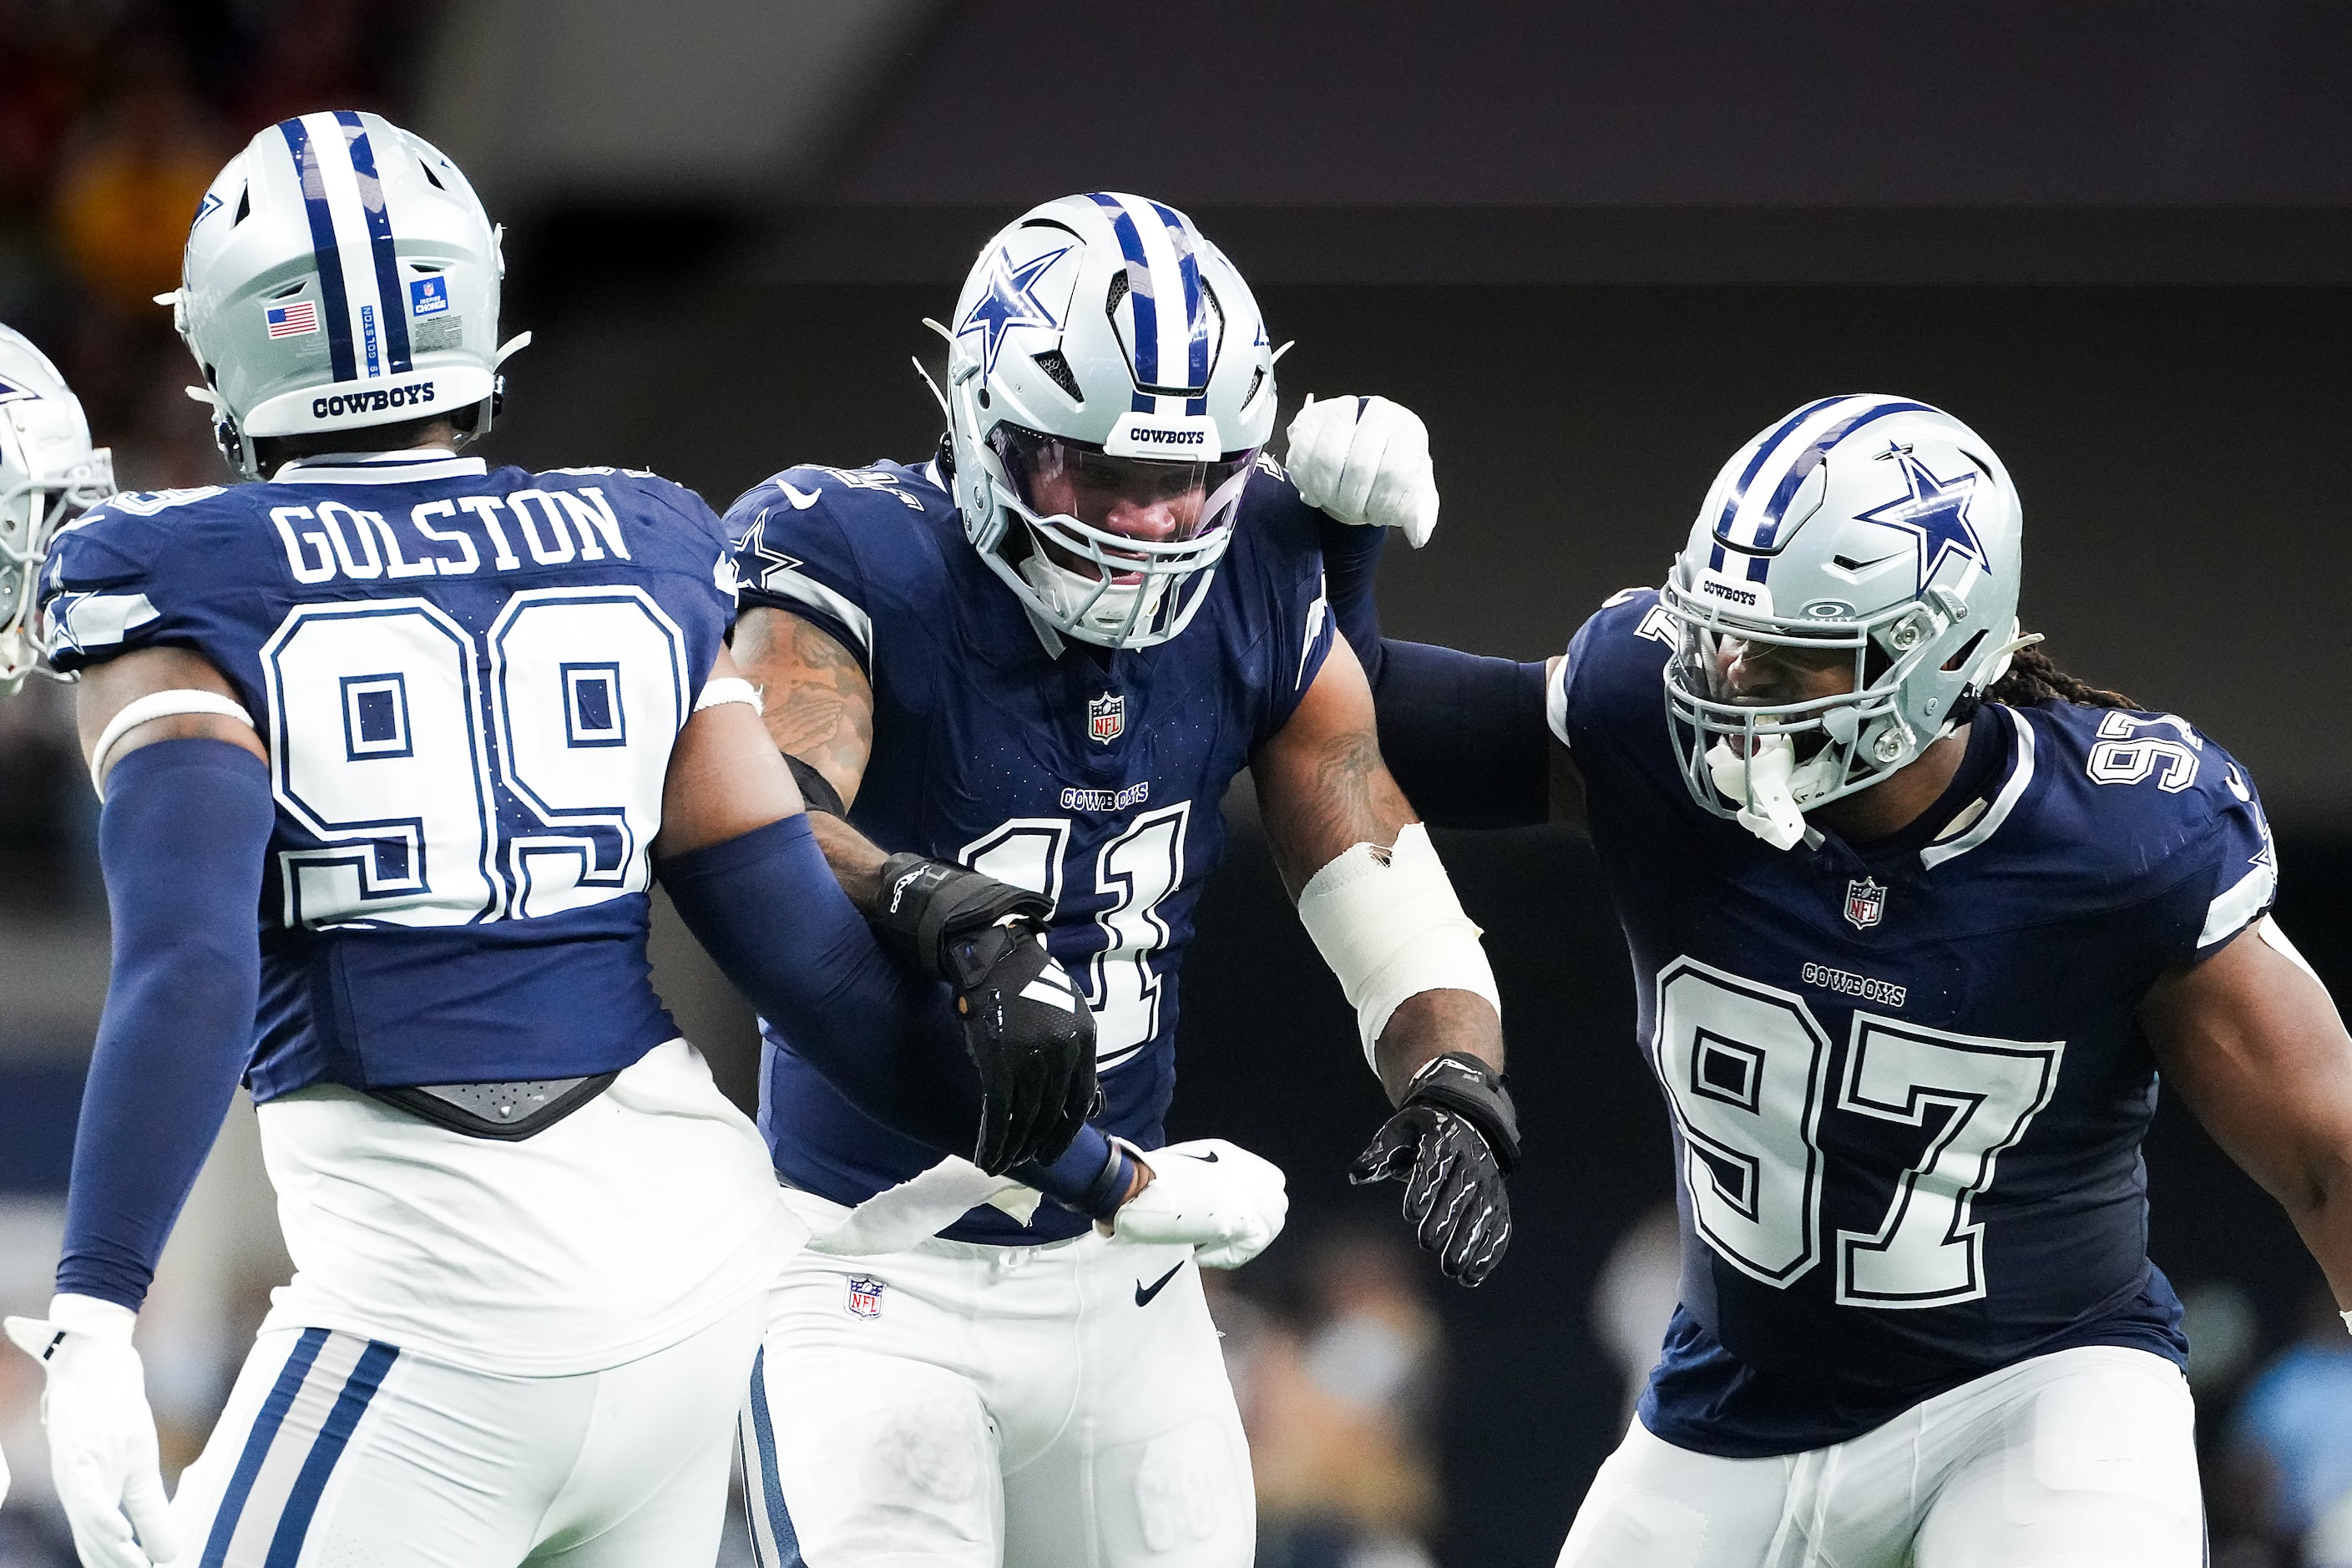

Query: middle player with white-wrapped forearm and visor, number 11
729;193;1517;1568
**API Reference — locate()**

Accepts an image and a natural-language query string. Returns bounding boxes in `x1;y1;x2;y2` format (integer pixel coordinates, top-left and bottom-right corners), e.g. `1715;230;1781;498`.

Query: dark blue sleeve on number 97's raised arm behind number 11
1319;519;1552;827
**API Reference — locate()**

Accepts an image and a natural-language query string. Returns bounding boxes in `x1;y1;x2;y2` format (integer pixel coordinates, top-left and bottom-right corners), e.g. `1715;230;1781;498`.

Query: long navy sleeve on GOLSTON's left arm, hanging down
57;741;276;1312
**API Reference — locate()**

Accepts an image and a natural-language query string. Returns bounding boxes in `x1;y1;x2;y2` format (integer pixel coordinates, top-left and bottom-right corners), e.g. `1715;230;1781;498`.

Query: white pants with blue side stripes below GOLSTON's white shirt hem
172;1297;766;1568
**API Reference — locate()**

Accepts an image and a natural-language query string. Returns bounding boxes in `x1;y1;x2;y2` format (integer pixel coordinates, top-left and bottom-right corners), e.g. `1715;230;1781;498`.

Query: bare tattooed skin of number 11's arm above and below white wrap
1249;642;1503;1100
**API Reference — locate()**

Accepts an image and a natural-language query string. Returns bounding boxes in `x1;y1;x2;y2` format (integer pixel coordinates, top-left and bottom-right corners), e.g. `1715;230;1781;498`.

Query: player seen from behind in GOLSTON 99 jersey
0;113;1094;1568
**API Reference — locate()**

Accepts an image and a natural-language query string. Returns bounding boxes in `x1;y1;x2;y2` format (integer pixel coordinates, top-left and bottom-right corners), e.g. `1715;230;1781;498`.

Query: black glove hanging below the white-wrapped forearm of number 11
1348;1051;1520;1286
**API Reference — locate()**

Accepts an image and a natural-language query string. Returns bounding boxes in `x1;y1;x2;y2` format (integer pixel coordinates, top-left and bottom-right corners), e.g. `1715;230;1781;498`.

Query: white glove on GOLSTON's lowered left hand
5;1295;179;1568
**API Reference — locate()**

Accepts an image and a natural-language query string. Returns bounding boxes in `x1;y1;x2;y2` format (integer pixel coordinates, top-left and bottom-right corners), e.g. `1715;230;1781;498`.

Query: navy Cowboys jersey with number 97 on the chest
1552;593;2277;1458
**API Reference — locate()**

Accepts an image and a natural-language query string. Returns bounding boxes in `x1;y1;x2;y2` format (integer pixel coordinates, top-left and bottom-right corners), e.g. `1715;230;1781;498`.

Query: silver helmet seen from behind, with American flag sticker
158;110;529;478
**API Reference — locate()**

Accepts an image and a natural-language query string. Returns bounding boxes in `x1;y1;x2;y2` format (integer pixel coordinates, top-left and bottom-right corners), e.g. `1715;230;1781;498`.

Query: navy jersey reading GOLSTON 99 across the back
43;453;734;1100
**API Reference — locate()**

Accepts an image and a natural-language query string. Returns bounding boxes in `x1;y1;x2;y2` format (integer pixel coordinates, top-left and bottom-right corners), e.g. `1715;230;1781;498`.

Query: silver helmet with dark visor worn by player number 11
945;190;1275;649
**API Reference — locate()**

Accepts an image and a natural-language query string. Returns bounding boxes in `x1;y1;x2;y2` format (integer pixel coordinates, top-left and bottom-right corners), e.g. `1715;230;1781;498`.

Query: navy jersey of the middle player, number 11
726;458;1331;1242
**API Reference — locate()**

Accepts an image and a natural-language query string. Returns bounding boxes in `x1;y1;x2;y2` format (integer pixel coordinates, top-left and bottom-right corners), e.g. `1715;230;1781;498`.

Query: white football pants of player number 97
1560;1345;2204;1568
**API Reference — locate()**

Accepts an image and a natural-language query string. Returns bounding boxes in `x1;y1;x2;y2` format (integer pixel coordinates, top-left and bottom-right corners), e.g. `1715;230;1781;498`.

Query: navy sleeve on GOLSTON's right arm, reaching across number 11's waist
659;816;1125;1213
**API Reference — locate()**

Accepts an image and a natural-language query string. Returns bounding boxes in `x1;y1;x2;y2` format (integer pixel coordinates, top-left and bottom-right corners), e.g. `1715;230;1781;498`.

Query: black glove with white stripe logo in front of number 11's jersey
875;856;1094;1176
